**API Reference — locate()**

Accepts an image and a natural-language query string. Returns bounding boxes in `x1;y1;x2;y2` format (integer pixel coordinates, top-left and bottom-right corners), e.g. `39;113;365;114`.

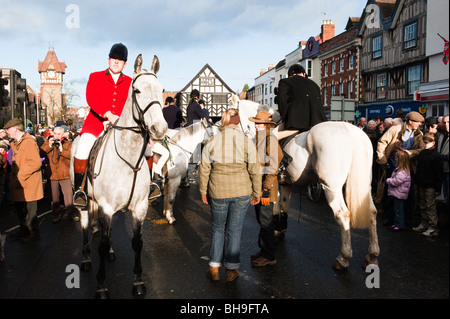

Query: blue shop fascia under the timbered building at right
355;101;426;118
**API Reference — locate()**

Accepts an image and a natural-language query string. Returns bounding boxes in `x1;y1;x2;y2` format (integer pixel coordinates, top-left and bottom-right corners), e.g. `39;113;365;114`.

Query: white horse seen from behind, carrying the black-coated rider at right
233;98;380;269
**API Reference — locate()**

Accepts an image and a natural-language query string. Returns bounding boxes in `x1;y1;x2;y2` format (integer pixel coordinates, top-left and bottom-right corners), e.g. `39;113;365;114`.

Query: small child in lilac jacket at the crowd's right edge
386;149;411;232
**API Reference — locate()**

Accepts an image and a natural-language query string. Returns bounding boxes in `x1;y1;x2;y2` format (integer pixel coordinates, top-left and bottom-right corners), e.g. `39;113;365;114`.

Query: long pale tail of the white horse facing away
345;131;376;228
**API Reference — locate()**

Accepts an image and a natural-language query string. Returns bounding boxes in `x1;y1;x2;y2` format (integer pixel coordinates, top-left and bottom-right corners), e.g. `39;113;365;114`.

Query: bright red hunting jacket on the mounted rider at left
81;69;132;137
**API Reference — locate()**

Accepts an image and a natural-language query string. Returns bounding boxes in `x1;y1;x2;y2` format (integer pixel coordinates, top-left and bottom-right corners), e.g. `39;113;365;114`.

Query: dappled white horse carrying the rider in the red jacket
70;55;167;298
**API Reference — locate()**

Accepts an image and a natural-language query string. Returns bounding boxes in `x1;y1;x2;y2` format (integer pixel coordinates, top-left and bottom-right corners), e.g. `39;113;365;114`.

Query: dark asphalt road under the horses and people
0;172;449;311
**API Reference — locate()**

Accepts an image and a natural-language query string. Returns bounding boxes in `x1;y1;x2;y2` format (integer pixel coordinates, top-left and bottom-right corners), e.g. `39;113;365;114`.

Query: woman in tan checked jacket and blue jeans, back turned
199;109;262;282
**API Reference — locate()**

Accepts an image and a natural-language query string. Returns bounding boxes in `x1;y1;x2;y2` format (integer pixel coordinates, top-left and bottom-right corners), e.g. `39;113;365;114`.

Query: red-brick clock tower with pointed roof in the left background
38;48;67;126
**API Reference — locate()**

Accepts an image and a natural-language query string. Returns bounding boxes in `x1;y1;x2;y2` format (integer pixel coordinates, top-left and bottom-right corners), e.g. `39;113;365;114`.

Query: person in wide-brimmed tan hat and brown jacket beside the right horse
249;111;283;267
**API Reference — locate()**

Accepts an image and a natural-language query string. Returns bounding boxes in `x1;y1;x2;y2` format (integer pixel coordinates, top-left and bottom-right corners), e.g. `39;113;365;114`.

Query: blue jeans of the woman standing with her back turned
209;195;250;269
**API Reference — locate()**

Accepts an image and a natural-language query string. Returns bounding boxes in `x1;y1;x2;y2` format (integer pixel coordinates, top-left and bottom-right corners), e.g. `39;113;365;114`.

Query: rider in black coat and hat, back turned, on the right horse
277;64;327;132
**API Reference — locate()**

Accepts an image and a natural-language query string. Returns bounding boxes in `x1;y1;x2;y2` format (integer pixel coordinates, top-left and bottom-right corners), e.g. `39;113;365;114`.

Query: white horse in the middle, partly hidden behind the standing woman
164;119;219;224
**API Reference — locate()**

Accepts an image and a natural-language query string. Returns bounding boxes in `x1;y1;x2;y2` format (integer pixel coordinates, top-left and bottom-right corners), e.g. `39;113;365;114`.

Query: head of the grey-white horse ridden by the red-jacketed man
131;54;167;139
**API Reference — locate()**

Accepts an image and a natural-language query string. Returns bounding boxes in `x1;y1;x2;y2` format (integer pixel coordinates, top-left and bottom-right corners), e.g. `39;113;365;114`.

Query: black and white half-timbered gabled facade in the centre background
180;64;235;117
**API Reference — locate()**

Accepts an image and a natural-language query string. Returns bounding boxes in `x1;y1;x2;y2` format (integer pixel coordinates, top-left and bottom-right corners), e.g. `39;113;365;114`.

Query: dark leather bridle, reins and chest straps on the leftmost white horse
92;72;161;208
